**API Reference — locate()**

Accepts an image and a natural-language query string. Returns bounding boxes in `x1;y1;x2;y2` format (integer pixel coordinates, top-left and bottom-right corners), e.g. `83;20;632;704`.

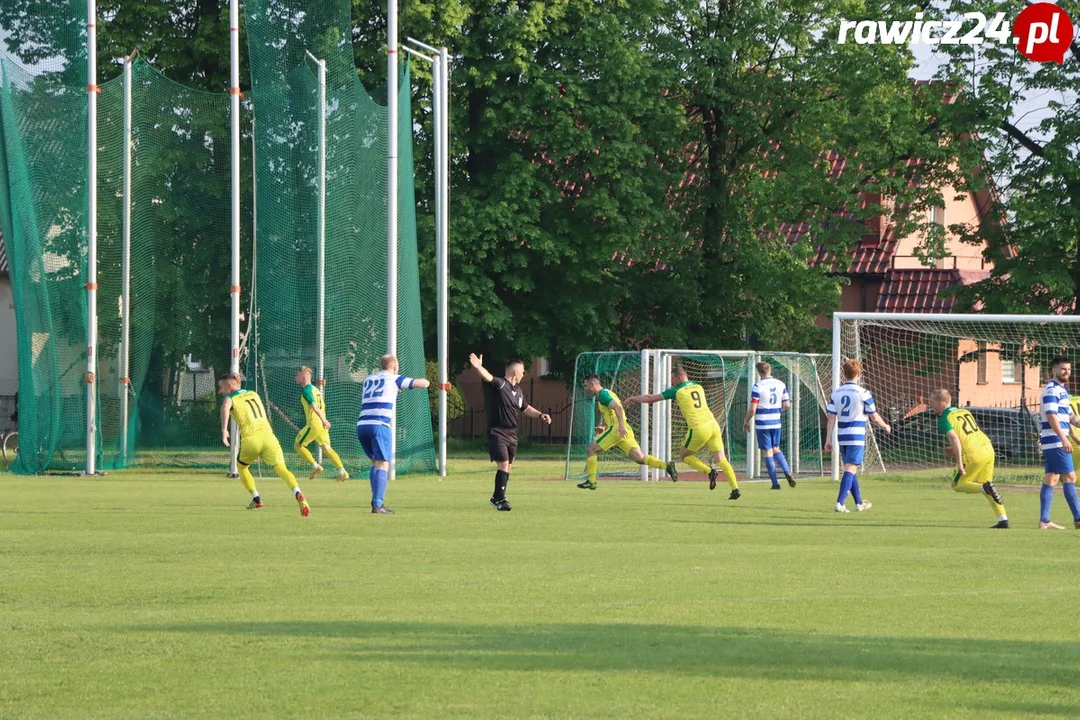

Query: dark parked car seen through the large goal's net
876;407;1040;460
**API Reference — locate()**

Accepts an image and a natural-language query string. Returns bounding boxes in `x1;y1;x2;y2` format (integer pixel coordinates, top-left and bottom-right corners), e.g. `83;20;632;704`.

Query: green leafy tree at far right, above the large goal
928;0;1080;313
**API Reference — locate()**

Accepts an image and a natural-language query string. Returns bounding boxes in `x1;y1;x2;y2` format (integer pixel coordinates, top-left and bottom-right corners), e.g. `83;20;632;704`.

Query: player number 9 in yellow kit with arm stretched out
626;366;742;500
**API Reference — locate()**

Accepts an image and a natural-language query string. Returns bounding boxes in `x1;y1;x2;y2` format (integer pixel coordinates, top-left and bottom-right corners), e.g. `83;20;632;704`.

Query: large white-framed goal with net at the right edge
833;313;1080;483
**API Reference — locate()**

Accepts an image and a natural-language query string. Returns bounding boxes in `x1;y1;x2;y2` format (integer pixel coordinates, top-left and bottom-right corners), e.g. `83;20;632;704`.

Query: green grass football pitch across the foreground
0;460;1080;719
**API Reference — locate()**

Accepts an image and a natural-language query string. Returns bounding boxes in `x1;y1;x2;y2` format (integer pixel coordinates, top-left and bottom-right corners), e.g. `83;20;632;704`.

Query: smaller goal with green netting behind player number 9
566;350;831;479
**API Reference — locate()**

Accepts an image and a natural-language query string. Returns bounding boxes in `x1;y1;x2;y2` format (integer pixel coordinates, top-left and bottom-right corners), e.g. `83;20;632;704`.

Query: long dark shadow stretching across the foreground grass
137;621;1080;699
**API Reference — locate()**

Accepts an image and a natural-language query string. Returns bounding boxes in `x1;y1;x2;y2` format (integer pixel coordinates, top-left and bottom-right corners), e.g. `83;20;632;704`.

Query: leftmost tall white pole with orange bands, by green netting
85;0;99;475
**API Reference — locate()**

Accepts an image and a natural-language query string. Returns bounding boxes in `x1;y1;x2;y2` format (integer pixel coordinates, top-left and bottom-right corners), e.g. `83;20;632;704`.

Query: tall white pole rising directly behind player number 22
387;0;397;479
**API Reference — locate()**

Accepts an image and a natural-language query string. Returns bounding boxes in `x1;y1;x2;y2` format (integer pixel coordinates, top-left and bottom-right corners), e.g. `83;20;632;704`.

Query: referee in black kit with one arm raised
469;353;551;513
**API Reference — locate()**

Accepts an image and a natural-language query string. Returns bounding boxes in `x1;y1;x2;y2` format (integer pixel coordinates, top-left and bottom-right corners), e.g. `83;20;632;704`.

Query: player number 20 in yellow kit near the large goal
930;389;1009;529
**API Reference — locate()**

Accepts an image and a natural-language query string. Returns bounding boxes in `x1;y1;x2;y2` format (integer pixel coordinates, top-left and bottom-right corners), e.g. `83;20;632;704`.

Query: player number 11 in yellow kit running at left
217;373;311;517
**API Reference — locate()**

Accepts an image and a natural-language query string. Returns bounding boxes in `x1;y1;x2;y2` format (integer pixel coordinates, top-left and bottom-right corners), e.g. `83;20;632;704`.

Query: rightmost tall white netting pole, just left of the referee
435;47;450;477
